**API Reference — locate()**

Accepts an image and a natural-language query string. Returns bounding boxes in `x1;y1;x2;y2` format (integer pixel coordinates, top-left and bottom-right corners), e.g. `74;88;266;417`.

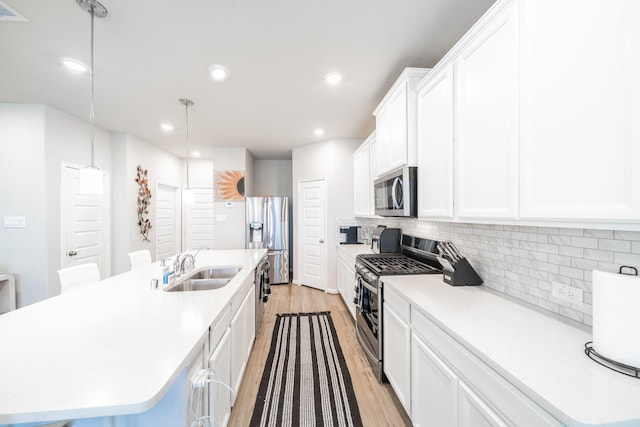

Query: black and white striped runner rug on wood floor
251;312;362;427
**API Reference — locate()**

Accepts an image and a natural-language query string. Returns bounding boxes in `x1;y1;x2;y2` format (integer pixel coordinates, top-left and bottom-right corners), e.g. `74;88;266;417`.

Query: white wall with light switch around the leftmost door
0;103;111;307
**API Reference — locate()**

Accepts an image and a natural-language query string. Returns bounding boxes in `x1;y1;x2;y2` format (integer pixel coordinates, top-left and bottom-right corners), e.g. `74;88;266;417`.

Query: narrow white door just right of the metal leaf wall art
156;184;180;260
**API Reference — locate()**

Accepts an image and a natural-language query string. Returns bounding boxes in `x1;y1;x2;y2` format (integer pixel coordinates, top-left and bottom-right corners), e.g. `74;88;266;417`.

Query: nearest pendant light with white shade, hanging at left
76;0;108;194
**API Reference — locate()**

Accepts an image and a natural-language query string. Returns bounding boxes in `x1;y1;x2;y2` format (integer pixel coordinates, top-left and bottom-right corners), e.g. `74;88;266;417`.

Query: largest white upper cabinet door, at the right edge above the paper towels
520;0;640;221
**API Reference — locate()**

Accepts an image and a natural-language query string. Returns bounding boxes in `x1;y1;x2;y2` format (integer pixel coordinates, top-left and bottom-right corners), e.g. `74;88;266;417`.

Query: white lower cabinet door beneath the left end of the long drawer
411;333;458;427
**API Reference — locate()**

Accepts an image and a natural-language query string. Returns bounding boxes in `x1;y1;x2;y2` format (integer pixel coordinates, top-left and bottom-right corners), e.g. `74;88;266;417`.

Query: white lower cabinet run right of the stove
382;286;563;427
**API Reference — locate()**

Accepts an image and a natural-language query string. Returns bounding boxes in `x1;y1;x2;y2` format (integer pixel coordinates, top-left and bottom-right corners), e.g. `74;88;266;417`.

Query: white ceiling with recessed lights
0;0;494;159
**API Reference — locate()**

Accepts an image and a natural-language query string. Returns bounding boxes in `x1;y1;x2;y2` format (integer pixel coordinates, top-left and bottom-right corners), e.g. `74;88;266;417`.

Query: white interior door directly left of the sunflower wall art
184;188;214;250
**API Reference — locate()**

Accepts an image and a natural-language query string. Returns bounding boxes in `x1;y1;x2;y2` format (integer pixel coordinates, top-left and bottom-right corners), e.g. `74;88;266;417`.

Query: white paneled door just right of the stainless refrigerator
298;179;327;290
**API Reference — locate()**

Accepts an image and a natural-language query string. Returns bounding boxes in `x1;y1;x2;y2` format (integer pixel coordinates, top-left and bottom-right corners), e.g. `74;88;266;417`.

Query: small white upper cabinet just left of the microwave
353;132;376;216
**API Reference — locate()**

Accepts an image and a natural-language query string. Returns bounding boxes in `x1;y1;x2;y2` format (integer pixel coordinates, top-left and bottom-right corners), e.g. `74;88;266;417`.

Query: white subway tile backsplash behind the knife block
352;218;640;326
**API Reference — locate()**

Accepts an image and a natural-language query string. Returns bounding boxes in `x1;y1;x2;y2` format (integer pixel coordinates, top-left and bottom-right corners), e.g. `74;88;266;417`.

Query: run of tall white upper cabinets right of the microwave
412;0;640;229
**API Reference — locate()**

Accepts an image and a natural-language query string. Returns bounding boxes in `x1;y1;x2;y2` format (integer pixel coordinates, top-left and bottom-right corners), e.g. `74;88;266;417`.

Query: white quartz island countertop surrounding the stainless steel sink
0;249;266;424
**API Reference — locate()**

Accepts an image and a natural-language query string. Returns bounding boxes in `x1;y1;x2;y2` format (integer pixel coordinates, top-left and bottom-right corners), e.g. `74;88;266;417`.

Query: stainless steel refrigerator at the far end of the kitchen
245;197;289;284
